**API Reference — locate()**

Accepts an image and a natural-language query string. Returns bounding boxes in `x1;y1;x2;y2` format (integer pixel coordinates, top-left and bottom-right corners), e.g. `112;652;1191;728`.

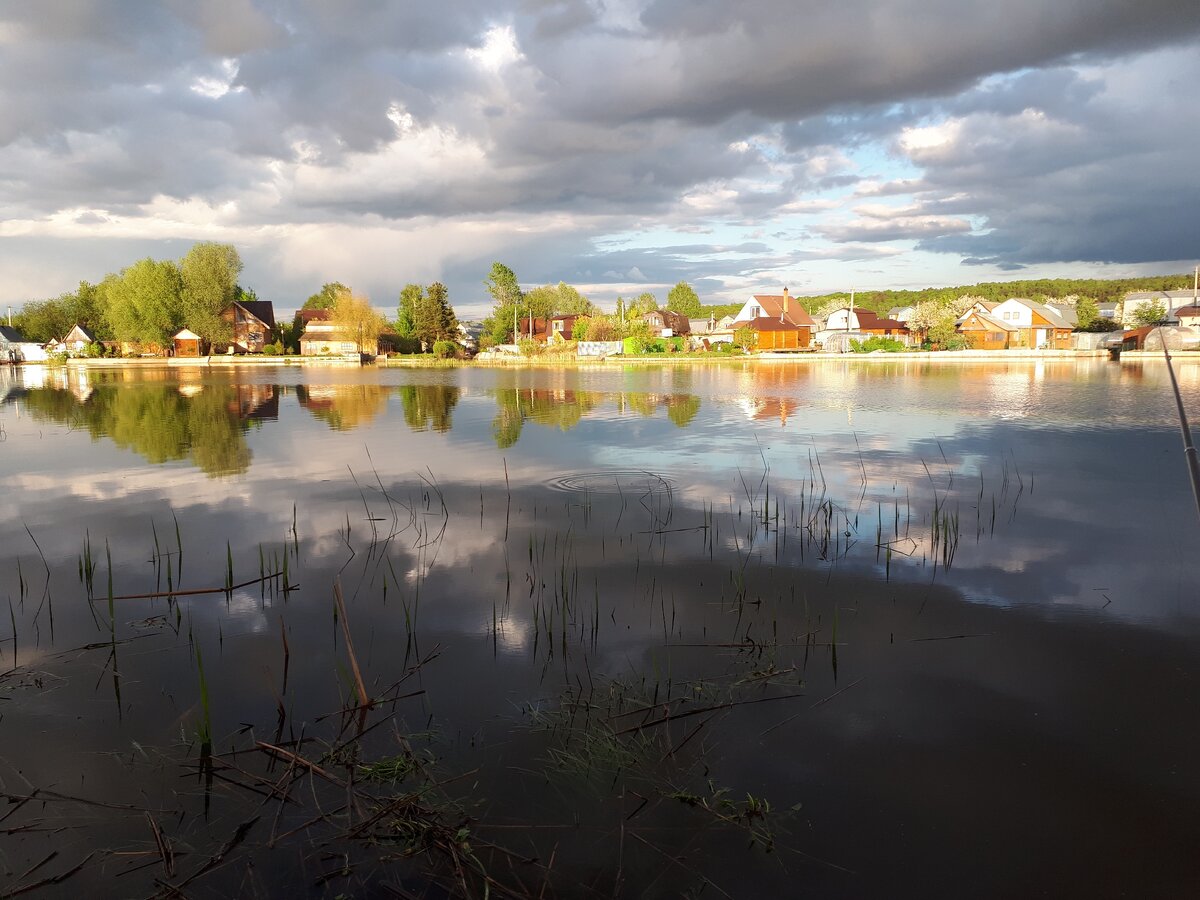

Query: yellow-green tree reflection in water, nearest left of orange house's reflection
492;388;701;450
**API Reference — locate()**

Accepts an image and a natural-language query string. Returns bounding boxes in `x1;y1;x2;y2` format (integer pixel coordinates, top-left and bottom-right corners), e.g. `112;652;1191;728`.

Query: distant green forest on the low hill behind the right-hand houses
704;272;1193;317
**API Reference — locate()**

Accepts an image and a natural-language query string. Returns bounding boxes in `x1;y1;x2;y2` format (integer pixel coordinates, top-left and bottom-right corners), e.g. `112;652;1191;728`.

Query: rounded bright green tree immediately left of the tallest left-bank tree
102;258;184;347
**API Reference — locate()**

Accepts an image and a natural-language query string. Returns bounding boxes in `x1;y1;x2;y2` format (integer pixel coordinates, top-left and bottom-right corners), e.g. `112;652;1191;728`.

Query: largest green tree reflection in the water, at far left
25;384;251;476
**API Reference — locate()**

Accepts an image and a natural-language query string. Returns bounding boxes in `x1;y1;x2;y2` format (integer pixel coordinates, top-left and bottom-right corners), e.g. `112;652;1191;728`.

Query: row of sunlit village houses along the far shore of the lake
0;287;1200;365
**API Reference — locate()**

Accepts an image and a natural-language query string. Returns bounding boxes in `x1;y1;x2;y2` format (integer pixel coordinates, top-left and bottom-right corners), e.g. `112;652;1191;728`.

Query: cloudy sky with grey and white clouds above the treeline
0;0;1200;316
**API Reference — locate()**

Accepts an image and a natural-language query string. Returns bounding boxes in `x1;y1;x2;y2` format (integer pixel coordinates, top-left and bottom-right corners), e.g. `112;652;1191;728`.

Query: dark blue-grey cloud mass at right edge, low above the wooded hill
914;52;1200;265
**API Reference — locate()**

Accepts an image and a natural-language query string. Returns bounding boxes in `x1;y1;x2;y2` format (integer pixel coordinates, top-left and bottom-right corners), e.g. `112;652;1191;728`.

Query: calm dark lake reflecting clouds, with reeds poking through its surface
0;359;1200;898
